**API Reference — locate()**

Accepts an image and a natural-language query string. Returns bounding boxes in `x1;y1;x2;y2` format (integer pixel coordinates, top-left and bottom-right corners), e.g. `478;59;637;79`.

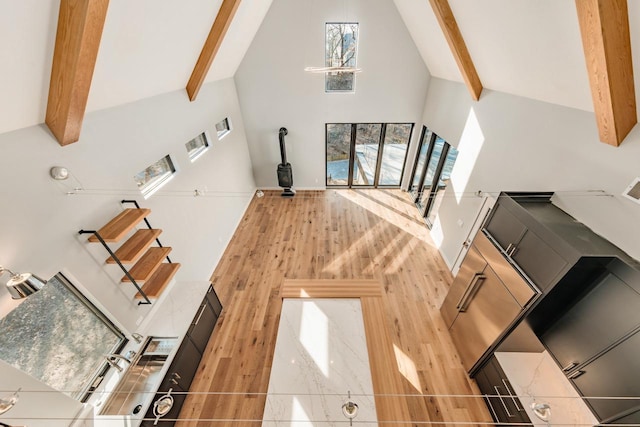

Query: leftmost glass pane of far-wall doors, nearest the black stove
327;123;351;185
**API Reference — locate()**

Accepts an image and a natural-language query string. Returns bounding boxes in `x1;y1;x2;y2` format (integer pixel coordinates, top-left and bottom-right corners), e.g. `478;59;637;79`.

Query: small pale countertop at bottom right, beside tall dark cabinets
495;351;598;427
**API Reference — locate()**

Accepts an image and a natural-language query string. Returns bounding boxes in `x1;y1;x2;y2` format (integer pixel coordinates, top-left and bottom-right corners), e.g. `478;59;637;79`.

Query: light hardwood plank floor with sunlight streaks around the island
176;190;491;427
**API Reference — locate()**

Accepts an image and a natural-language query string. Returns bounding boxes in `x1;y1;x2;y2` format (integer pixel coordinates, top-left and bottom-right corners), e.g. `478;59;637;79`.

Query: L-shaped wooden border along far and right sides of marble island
280;279;412;424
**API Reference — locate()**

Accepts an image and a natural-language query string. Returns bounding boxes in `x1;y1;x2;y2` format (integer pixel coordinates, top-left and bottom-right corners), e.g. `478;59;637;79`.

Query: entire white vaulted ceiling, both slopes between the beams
0;0;640;133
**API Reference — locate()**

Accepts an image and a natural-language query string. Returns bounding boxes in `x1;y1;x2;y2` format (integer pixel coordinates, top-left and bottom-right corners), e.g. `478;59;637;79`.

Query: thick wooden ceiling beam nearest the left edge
45;0;109;145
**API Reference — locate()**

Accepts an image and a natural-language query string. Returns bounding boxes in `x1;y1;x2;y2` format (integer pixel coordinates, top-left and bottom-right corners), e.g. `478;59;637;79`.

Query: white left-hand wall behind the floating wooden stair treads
0;79;255;426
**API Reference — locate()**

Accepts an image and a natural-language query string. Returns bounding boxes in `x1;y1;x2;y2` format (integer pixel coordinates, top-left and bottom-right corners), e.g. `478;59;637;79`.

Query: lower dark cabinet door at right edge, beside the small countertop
569;331;640;422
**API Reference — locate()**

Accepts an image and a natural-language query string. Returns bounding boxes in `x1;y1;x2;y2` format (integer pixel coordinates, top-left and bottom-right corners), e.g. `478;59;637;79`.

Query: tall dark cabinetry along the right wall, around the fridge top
477;193;640;423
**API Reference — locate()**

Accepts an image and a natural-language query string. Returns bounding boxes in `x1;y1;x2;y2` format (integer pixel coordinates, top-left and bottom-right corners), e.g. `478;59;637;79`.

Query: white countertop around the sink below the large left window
84;281;210;427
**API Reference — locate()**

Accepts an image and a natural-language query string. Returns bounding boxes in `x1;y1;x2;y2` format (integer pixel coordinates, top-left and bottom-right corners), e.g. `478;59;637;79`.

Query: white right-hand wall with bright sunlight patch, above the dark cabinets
423;78;640;266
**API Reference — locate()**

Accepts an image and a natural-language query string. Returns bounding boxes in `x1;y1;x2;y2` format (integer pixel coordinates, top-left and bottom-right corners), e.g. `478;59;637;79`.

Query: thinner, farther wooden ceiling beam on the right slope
429;0;482;101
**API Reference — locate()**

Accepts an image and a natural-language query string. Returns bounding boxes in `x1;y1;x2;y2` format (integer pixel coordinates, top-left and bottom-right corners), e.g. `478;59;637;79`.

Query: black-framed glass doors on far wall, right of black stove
326;123;413;187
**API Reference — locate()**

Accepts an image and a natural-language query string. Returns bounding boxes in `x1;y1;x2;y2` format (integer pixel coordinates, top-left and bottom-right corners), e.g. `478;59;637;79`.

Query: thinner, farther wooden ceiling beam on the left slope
187;0;240;101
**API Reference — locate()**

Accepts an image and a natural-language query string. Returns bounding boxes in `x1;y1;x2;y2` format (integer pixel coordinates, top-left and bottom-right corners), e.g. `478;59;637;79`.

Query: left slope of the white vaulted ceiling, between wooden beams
0;0;272;133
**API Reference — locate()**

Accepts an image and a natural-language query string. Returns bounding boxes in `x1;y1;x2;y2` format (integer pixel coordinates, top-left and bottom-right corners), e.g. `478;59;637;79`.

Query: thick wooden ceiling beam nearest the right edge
576;0;638;146
